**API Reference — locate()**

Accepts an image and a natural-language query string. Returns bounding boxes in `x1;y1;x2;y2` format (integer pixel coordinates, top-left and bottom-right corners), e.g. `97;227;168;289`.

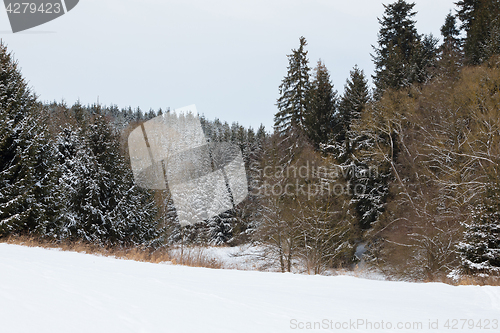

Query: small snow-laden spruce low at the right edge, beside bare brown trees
457;183;500;277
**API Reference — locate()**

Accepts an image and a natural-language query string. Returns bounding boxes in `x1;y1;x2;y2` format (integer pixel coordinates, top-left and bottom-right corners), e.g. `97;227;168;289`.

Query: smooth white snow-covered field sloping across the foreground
0;244;500;333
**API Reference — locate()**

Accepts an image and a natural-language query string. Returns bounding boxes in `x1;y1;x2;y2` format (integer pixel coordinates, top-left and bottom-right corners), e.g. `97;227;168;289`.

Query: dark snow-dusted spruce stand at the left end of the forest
0;57;161;246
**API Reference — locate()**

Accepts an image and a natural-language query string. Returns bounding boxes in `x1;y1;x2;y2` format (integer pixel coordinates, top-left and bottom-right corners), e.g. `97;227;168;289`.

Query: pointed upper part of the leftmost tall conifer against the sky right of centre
274;37;311;134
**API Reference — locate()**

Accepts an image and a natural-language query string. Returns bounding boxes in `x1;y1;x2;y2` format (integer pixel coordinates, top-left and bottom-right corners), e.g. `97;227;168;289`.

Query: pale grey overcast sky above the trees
0;0;455;130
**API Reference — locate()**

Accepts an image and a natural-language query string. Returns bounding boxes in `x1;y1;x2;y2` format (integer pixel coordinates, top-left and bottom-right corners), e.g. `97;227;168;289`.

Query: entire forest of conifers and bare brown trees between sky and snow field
0;0;500;281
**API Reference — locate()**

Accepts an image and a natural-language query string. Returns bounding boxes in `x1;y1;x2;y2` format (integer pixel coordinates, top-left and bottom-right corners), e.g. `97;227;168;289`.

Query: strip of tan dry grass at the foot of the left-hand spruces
0;236;224;269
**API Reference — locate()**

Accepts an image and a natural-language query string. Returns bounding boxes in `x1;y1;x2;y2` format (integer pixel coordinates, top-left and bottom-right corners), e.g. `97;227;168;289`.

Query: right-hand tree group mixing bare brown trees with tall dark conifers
257;0;500;280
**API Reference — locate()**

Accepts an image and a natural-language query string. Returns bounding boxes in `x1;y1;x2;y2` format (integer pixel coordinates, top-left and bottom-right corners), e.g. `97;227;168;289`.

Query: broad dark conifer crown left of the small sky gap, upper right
372;0;437;99
